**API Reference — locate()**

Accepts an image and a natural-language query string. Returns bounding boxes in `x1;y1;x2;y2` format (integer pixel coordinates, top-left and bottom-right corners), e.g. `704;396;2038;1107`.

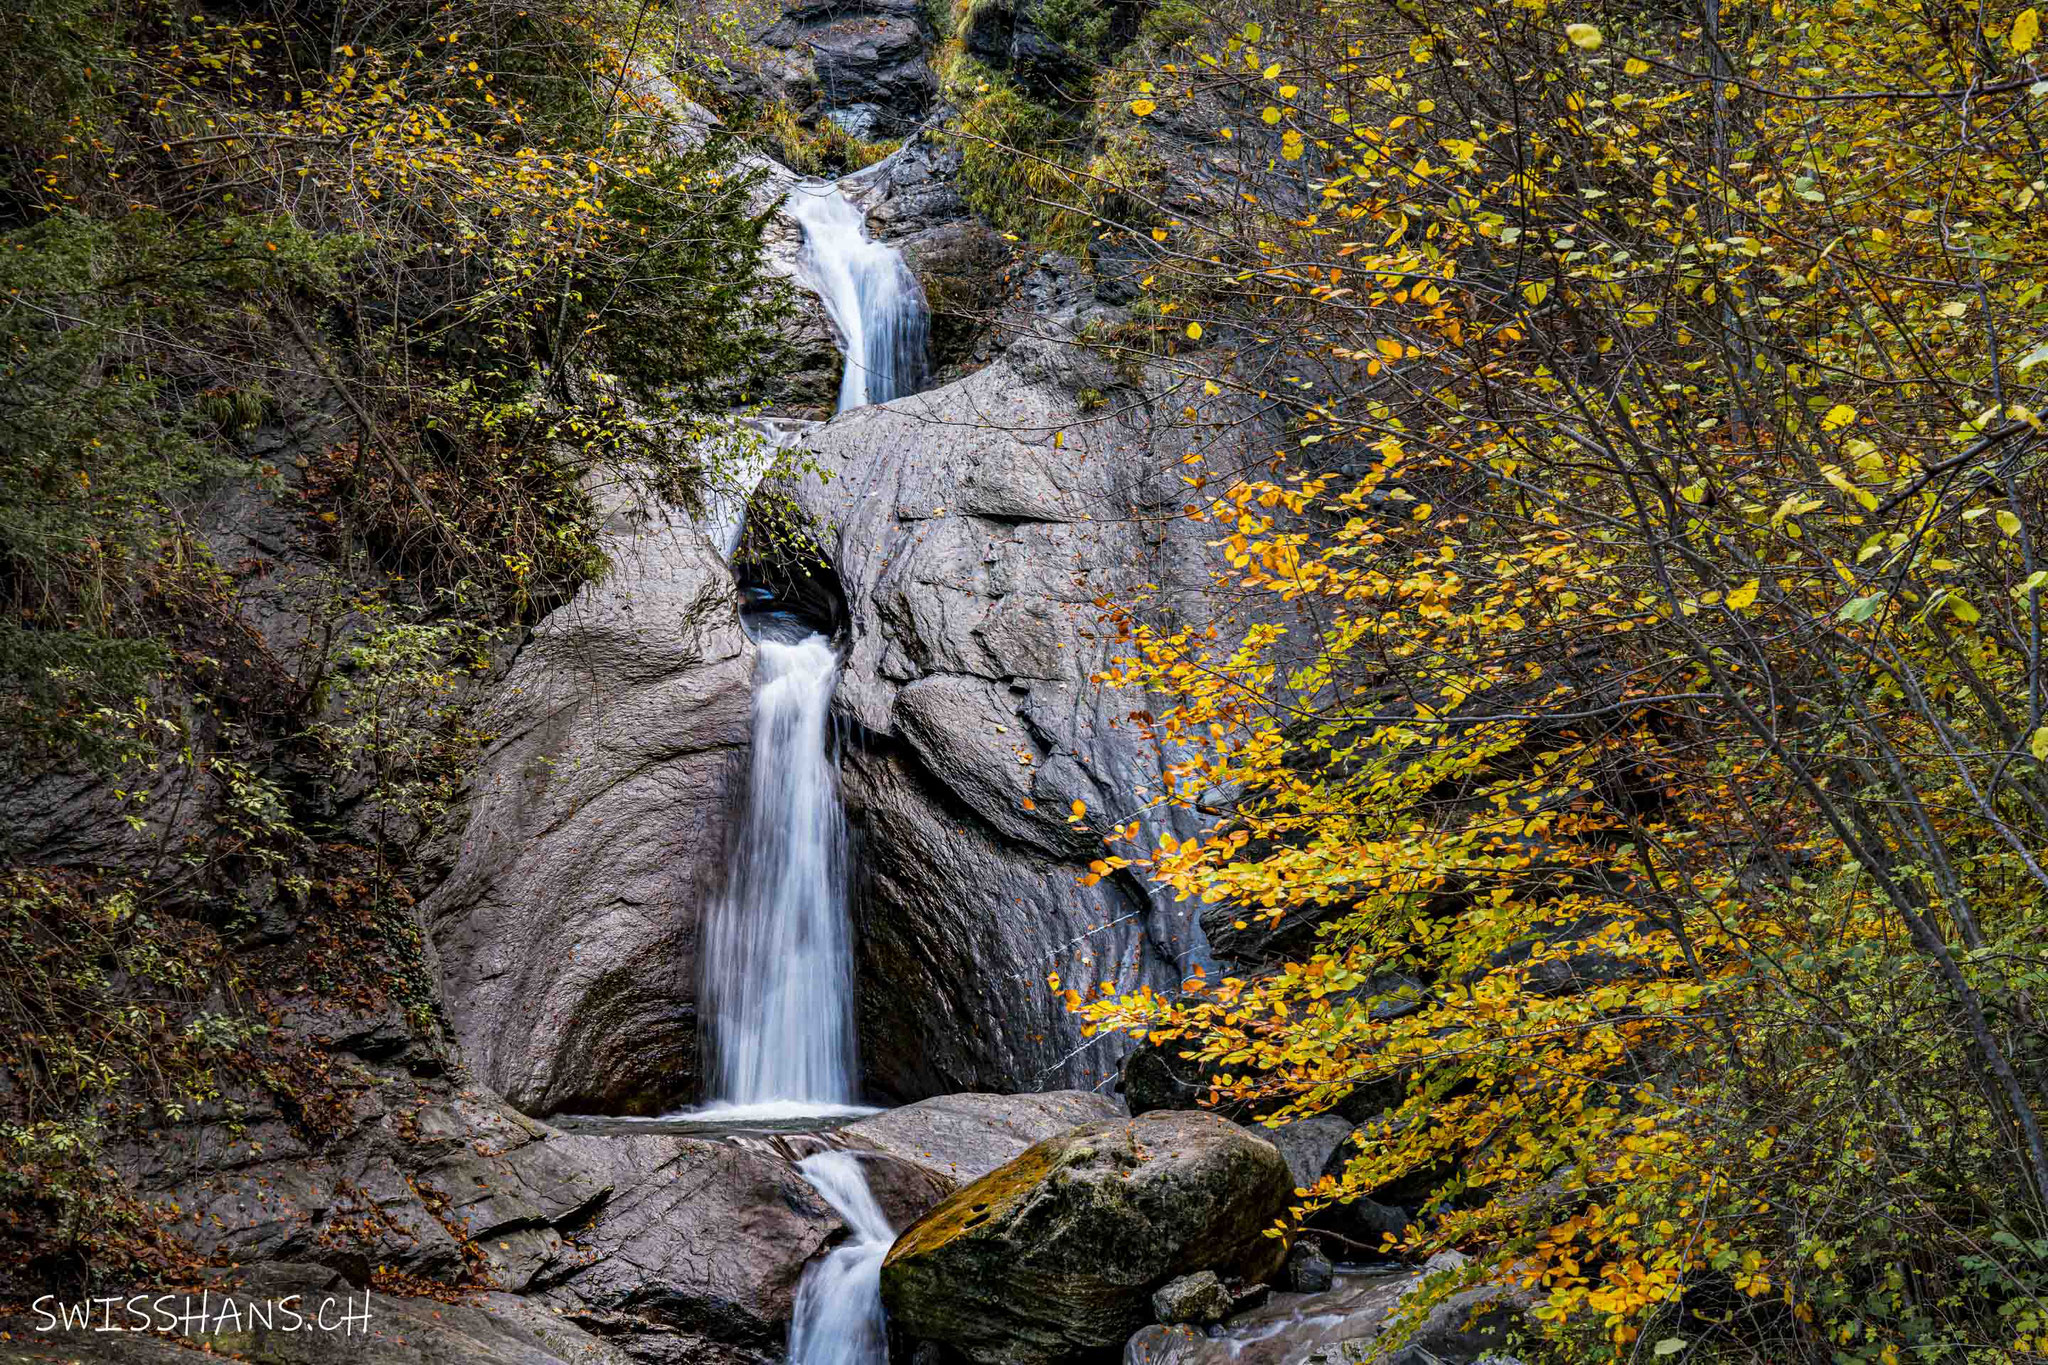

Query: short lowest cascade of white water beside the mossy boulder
788;1152;895;1365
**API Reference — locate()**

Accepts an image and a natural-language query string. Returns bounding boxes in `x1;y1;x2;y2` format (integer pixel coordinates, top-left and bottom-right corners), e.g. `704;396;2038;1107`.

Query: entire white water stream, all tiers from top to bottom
694;170;926;1365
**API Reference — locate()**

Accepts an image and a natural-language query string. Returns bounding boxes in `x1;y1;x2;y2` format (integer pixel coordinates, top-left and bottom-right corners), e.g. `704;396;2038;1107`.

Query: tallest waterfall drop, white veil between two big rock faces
700;622;858;1117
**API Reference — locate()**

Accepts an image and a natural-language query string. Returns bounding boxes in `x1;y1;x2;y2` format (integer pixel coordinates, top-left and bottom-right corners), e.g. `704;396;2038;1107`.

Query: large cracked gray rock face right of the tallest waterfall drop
793;307;1255;1099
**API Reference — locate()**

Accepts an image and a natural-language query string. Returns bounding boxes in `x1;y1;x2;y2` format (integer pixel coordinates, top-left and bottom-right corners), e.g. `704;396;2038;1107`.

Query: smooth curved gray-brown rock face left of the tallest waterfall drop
424;482;754;1113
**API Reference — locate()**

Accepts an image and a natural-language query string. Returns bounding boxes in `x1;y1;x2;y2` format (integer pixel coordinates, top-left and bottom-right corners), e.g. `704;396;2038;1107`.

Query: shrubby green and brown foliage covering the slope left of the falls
0;0;806;1291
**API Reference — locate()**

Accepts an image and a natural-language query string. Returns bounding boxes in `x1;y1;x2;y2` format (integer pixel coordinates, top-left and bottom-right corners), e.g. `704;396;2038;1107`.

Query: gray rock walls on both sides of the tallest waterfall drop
426;274;1261;1113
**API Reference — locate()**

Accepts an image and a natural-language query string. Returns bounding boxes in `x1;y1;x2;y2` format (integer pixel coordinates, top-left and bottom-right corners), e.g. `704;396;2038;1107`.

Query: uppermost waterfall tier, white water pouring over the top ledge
786;184;926;411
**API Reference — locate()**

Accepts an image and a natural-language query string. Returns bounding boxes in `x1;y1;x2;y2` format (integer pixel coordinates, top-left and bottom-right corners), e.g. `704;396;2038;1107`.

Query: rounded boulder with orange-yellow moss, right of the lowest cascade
883;1111;1294;1365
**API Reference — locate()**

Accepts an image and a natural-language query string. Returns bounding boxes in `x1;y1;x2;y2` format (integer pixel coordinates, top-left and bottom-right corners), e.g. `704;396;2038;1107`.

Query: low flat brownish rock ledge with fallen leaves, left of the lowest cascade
111;1074;847;1361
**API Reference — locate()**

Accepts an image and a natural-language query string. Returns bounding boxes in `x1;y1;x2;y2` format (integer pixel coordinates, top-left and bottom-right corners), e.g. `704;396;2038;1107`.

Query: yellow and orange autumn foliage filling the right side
1069;0;2048;1365
